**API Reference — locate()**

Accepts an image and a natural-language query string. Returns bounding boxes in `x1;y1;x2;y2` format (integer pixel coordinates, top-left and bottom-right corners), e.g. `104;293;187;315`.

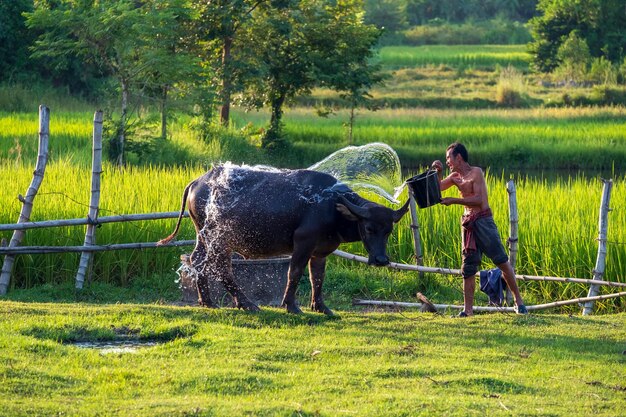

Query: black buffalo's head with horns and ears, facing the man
337;197;409;266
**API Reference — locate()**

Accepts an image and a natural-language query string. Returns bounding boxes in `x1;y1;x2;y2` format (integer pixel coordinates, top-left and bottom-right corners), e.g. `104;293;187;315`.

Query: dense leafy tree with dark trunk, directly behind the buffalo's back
247;0;380;147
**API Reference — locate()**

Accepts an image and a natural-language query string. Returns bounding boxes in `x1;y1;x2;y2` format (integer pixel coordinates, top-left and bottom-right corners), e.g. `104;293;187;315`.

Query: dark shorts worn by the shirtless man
461;216;509;278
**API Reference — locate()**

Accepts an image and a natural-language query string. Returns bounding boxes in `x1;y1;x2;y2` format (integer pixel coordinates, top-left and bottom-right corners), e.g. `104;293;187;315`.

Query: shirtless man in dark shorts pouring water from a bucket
431;142;528;317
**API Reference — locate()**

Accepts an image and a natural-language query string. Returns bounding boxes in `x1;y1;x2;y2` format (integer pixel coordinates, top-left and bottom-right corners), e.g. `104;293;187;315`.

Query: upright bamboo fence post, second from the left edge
76;110;102;290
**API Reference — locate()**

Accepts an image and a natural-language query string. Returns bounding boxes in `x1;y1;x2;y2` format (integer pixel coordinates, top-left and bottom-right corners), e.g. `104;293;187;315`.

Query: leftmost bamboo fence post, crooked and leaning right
0;105;50;295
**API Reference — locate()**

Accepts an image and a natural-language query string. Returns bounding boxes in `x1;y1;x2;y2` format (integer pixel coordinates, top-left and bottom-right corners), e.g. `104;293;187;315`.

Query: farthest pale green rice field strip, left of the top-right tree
378;45;530;69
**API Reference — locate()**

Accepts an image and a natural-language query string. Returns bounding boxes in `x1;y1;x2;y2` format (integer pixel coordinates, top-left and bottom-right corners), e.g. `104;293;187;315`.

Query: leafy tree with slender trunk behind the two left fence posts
27;0;196;165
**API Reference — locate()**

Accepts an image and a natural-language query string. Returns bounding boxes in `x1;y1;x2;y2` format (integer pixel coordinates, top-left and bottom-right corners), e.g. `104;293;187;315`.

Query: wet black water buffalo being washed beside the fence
159;164;408;314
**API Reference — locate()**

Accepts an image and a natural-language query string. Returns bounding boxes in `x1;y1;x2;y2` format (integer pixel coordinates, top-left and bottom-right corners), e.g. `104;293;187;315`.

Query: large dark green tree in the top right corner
529;0;626;72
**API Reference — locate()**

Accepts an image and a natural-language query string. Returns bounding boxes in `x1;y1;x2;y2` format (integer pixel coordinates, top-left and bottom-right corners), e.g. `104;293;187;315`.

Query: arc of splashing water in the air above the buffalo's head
309;142;404;204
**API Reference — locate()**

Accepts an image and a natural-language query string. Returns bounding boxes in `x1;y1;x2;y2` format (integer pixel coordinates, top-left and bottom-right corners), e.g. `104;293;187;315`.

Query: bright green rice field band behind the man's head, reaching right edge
276;109;626;173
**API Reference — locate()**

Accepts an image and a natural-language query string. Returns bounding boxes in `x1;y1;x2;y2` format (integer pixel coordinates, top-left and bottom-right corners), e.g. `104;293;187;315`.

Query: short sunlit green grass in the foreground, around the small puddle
0;301;626;416
